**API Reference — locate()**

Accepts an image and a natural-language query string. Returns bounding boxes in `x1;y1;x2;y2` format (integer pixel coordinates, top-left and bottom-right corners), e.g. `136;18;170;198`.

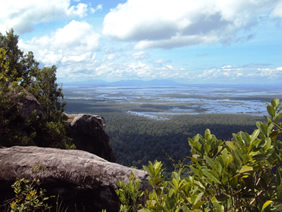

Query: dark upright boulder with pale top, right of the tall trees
66;114;115;162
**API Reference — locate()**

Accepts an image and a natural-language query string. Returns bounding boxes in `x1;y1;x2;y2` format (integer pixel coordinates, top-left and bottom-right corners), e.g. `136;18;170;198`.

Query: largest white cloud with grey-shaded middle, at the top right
103;0;282;49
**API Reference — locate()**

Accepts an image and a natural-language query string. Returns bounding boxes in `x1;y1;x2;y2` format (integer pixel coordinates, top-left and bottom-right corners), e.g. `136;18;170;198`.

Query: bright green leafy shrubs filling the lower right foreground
118;99;282;212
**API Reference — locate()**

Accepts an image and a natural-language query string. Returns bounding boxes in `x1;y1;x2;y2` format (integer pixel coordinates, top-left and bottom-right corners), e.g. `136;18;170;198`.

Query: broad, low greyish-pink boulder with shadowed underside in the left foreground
0;146;150;211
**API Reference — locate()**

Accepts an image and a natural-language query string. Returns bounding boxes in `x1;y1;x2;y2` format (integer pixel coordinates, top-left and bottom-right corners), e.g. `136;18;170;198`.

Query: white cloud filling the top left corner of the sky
0;0;88;34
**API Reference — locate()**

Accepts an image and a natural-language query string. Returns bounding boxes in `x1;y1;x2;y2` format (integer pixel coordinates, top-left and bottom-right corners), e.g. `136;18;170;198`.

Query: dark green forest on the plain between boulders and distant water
66;97;264;171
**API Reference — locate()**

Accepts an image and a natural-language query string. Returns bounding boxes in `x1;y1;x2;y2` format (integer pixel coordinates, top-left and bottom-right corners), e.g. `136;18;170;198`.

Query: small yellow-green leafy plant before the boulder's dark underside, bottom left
10;178;52;212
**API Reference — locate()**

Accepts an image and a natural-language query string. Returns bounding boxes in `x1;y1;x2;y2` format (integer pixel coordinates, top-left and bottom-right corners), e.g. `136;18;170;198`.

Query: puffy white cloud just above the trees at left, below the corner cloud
19;21;100;65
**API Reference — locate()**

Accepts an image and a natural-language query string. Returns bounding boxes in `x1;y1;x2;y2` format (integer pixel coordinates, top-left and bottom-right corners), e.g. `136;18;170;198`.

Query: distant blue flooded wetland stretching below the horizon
63;85;282;119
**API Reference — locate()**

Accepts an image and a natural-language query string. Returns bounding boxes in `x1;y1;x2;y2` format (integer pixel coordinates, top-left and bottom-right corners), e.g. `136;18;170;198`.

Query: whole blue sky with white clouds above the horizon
0;0;282;84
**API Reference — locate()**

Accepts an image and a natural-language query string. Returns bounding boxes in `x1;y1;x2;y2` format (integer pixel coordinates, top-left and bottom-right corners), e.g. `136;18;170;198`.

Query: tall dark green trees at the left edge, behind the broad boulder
0;30;75;148
